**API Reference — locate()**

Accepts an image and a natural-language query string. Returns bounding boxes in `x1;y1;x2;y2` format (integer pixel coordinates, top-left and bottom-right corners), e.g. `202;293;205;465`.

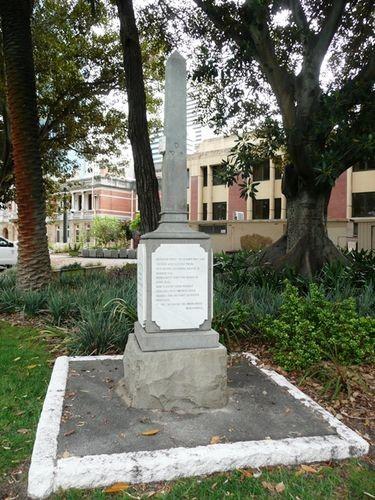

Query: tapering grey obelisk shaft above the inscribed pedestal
161;50;187;223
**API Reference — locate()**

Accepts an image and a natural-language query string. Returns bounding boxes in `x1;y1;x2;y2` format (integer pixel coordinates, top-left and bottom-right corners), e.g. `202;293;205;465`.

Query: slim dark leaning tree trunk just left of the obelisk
116;0;160;232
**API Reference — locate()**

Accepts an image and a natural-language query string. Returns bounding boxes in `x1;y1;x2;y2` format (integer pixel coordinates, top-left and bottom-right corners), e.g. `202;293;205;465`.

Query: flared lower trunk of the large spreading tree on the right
262;168;345;277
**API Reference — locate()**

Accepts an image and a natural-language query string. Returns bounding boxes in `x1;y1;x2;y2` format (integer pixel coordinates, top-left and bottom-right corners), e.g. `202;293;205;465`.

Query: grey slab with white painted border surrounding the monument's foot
29;355;368;498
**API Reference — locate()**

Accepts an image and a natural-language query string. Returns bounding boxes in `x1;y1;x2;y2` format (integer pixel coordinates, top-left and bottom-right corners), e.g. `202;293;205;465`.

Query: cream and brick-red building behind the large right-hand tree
187;137;375;250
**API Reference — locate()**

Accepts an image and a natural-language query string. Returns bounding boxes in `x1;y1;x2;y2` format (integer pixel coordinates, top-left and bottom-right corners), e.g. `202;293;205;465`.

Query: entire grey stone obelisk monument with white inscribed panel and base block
124;51;227;410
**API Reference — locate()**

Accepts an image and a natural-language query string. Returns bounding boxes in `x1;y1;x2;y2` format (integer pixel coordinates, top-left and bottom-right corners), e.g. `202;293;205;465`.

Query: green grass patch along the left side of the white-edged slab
0;321;51;480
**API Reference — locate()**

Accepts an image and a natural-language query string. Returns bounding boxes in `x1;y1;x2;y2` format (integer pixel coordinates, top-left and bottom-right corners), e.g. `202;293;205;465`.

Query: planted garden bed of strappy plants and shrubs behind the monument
0;253;375;468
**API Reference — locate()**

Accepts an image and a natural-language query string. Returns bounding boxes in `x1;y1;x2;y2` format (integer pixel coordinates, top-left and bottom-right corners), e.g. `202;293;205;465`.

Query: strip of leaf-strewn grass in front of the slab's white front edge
53;460;375;500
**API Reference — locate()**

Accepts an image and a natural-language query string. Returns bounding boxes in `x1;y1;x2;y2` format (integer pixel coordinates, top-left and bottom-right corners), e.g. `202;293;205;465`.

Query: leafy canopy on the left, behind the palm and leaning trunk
0;0;165;202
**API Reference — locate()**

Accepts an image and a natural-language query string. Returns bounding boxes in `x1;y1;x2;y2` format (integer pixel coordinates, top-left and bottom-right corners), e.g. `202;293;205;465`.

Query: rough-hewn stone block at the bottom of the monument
117;334;228;410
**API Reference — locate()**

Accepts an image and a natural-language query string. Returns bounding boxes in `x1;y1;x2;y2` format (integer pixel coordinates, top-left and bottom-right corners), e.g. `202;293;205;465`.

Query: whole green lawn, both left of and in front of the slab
0;321;375;500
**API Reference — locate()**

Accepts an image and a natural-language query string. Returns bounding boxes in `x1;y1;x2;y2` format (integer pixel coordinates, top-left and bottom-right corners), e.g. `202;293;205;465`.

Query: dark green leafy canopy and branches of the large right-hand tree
155;0;375;191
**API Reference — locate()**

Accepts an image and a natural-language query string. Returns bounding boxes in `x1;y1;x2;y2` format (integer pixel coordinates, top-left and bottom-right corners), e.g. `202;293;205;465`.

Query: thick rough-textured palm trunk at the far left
0;0;51;289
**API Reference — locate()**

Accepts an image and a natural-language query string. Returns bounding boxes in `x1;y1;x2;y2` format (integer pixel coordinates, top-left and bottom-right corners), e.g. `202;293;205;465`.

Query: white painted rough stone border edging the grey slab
28;353;369;498
